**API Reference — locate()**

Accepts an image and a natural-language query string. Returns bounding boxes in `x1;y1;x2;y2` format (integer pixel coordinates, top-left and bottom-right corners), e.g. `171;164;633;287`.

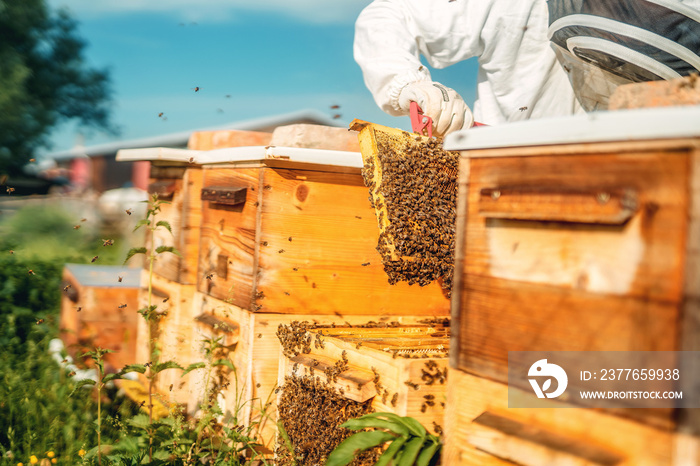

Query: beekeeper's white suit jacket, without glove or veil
354;0;583;125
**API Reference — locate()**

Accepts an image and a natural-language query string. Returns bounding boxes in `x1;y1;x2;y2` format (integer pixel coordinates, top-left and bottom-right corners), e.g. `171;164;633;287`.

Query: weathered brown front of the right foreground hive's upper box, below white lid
455;145;689;381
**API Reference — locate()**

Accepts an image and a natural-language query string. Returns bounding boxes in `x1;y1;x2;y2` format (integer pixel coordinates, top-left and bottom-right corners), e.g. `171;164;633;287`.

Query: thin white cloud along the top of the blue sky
48;0;371;24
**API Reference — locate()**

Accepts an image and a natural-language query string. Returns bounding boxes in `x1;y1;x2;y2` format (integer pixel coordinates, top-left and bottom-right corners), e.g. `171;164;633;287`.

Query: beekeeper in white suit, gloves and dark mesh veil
354;0;700;135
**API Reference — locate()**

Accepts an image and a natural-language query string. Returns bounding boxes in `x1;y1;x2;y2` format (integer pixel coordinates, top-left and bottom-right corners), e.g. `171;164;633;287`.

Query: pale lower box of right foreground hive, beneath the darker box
443;370;674;466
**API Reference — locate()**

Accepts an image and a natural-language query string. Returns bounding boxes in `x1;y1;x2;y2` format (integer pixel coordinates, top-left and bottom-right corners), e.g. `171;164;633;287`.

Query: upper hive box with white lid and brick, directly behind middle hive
117;131;272;285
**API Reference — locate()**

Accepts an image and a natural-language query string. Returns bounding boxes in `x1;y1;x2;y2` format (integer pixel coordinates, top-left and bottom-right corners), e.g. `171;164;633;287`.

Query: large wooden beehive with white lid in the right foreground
445;108;700;465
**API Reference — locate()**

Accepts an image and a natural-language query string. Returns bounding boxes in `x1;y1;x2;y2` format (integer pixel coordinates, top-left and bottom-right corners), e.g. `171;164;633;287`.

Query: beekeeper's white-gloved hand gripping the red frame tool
398;81;474;136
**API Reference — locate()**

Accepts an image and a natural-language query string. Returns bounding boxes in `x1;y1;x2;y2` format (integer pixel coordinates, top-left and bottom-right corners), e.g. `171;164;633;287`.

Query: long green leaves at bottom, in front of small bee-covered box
326;413;441;466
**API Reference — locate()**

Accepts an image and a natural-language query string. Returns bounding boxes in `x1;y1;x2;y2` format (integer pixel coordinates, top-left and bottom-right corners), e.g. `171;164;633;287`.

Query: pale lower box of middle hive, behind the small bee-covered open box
158;292;432;452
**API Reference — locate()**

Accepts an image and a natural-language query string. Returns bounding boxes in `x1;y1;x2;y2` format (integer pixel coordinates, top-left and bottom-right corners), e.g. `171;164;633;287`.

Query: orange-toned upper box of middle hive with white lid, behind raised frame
198;147;449;316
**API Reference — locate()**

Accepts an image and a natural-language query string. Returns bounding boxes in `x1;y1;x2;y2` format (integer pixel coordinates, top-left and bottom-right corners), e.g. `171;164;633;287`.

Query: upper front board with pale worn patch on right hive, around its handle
464;151;688;302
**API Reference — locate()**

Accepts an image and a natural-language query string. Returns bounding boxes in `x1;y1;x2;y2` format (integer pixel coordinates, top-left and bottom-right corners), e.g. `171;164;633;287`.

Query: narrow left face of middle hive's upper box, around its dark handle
197;167;262;309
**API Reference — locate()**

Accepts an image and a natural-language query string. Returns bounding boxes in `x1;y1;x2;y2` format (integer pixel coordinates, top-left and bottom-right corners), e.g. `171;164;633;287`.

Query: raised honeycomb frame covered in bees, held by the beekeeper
362;128;459;296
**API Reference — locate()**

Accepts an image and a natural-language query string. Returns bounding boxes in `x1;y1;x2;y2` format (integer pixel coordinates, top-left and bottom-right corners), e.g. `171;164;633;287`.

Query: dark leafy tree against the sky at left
0;0;115;176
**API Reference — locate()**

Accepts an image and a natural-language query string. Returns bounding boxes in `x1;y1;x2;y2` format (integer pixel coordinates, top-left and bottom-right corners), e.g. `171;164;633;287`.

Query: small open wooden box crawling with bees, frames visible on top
278;319;449;464
